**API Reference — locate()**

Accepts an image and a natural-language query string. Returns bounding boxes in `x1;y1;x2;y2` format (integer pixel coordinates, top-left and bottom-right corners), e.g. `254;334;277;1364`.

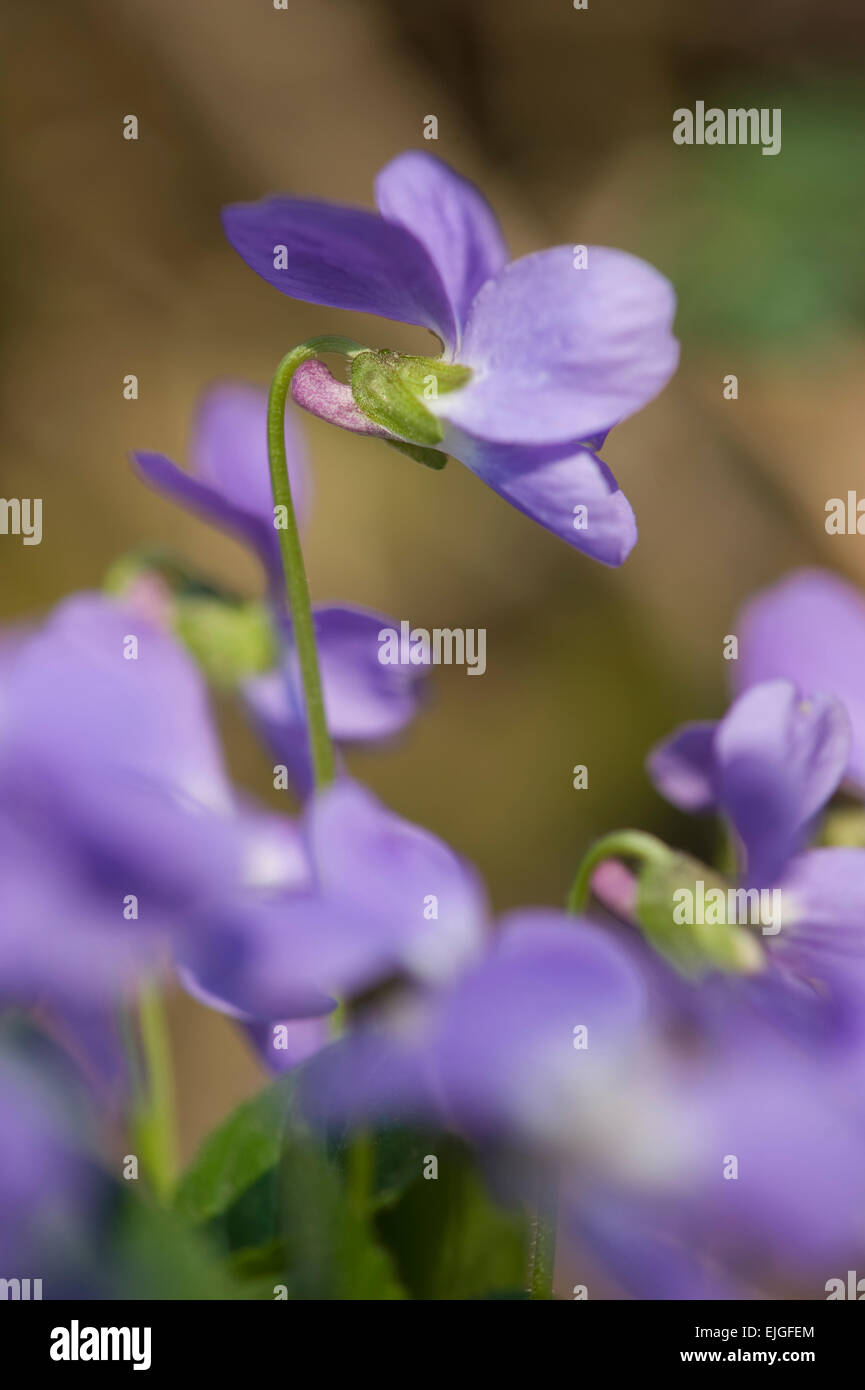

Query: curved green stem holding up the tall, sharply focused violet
267;336;364;788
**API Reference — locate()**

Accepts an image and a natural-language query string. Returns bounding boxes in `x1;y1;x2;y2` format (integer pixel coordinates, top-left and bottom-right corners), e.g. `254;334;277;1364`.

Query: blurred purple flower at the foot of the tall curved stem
185;778;487;1023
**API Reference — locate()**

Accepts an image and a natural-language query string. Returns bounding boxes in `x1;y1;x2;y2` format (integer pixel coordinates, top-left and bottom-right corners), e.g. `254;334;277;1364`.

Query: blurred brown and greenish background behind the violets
0;0;865;1150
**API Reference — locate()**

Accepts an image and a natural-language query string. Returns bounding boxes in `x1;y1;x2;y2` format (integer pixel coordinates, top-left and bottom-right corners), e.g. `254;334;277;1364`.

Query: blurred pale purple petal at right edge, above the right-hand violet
730;570;865;787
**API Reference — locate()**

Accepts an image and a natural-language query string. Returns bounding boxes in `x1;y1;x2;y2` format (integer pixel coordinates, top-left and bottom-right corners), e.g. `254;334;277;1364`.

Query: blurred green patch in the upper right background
640;82;865;352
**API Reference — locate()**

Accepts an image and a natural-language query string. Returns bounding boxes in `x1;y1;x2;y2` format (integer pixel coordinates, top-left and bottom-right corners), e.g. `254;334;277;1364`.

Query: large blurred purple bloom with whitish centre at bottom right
303;912;865;1298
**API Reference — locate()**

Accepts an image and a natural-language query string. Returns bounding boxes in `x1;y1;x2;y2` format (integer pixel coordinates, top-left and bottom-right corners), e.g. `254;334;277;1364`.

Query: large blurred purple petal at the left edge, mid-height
0;595;298;930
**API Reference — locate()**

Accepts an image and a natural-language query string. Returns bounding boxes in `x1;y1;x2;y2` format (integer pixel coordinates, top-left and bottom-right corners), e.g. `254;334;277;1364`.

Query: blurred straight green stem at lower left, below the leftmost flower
135;984;178;1202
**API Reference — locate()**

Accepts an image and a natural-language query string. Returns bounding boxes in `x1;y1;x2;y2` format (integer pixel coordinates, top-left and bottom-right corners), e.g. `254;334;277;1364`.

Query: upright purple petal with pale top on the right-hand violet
715;681;850;883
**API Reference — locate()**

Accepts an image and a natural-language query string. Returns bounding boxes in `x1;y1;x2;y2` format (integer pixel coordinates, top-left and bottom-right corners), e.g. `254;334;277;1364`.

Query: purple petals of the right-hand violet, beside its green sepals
648;680;865;992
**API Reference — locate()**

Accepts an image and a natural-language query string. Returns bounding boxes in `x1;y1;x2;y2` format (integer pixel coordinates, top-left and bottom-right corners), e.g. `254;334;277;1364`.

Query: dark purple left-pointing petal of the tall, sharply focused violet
223;197;455;343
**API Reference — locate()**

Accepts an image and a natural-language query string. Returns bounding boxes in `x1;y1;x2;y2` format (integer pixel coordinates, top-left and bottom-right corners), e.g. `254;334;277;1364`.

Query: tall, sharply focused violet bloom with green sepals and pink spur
224;152;677;564
